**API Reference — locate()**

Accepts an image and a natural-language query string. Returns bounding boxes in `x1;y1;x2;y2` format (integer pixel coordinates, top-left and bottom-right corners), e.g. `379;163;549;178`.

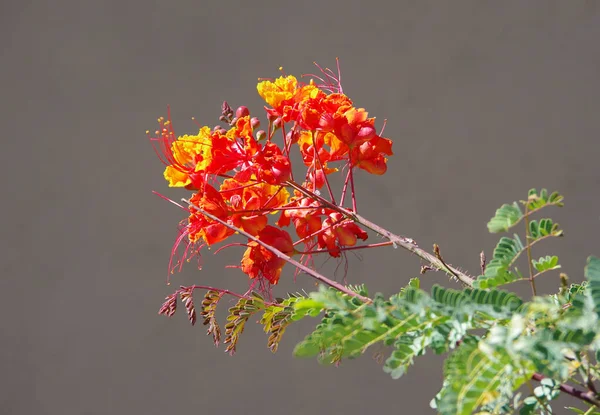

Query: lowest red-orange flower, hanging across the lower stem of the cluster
242;226;295;284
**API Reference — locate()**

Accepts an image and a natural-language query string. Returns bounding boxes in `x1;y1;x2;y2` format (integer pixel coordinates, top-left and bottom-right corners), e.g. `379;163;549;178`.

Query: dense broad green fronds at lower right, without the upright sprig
294;270;600;414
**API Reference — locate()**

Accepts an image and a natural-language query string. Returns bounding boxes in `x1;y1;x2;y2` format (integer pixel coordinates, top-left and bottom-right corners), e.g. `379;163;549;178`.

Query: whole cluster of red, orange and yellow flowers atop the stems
150;62;392;290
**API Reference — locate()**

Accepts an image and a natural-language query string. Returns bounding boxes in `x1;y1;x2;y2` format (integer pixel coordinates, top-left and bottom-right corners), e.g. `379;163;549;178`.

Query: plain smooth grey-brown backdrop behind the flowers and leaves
0;0;600;414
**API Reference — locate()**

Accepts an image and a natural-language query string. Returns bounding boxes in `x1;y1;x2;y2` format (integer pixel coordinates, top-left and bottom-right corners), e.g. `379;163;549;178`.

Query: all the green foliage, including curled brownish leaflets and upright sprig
160;189;600;415
